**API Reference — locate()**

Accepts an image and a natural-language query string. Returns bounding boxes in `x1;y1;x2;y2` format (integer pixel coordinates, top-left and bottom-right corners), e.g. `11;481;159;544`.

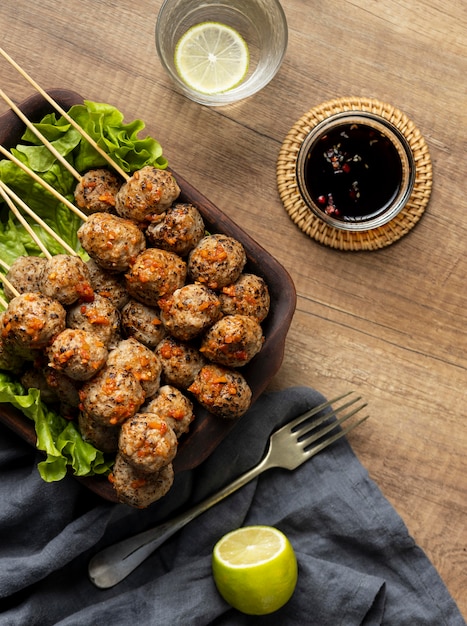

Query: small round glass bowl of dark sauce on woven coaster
296;111;416;231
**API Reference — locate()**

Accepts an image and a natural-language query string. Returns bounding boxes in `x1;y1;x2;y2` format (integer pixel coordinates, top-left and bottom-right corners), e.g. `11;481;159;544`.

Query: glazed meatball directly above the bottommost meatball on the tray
118;413;178;473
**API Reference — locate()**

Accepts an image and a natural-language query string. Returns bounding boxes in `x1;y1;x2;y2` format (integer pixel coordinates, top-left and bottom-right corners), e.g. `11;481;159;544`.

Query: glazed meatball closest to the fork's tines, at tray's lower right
188;363;251;419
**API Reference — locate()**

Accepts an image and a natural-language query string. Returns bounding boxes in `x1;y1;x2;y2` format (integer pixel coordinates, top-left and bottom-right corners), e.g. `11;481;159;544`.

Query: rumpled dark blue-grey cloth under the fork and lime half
0;387;466;626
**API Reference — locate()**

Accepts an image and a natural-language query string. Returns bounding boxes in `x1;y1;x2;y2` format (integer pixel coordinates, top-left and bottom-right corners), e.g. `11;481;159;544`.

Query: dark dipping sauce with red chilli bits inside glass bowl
304;123;402;221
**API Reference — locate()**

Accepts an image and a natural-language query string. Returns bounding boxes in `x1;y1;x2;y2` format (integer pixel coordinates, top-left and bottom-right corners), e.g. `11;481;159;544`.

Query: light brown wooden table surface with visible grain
0;0;467;617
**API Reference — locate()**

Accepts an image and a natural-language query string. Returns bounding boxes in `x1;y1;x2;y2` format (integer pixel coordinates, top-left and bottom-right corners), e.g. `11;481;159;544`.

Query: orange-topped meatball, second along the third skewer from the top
125;248;186;306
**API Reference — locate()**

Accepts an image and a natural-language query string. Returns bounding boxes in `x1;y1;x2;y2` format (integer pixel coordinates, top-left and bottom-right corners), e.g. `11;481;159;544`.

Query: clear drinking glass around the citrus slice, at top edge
156;0;288;106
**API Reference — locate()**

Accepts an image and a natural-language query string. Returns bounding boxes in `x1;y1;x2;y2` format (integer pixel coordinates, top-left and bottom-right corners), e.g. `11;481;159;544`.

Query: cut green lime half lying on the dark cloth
212;526;298;615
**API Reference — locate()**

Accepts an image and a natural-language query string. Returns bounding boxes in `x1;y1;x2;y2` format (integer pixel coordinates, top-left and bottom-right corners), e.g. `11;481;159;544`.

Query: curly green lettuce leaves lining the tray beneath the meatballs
0;100;168;482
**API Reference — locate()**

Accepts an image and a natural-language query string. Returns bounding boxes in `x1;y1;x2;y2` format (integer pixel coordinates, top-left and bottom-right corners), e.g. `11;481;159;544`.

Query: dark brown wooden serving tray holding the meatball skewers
0;89;296;501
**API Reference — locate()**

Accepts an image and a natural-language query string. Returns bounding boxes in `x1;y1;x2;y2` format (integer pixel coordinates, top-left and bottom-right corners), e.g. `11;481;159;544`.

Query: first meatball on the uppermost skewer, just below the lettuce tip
115;165;180;222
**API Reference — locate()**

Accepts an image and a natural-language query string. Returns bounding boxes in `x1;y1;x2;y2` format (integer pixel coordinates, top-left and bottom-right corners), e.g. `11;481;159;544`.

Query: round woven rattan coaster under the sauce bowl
277;98;432;250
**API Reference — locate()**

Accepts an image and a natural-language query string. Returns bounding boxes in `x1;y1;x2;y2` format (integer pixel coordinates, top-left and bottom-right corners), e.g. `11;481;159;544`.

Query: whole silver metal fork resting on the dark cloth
88;392;369;589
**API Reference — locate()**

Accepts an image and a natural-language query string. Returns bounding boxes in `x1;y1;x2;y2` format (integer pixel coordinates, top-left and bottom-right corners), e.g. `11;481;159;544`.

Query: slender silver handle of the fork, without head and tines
88;457;271;589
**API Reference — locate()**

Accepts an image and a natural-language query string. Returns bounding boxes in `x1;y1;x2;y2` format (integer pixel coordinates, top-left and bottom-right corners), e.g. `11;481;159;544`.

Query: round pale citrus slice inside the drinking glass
174;22;250;95
